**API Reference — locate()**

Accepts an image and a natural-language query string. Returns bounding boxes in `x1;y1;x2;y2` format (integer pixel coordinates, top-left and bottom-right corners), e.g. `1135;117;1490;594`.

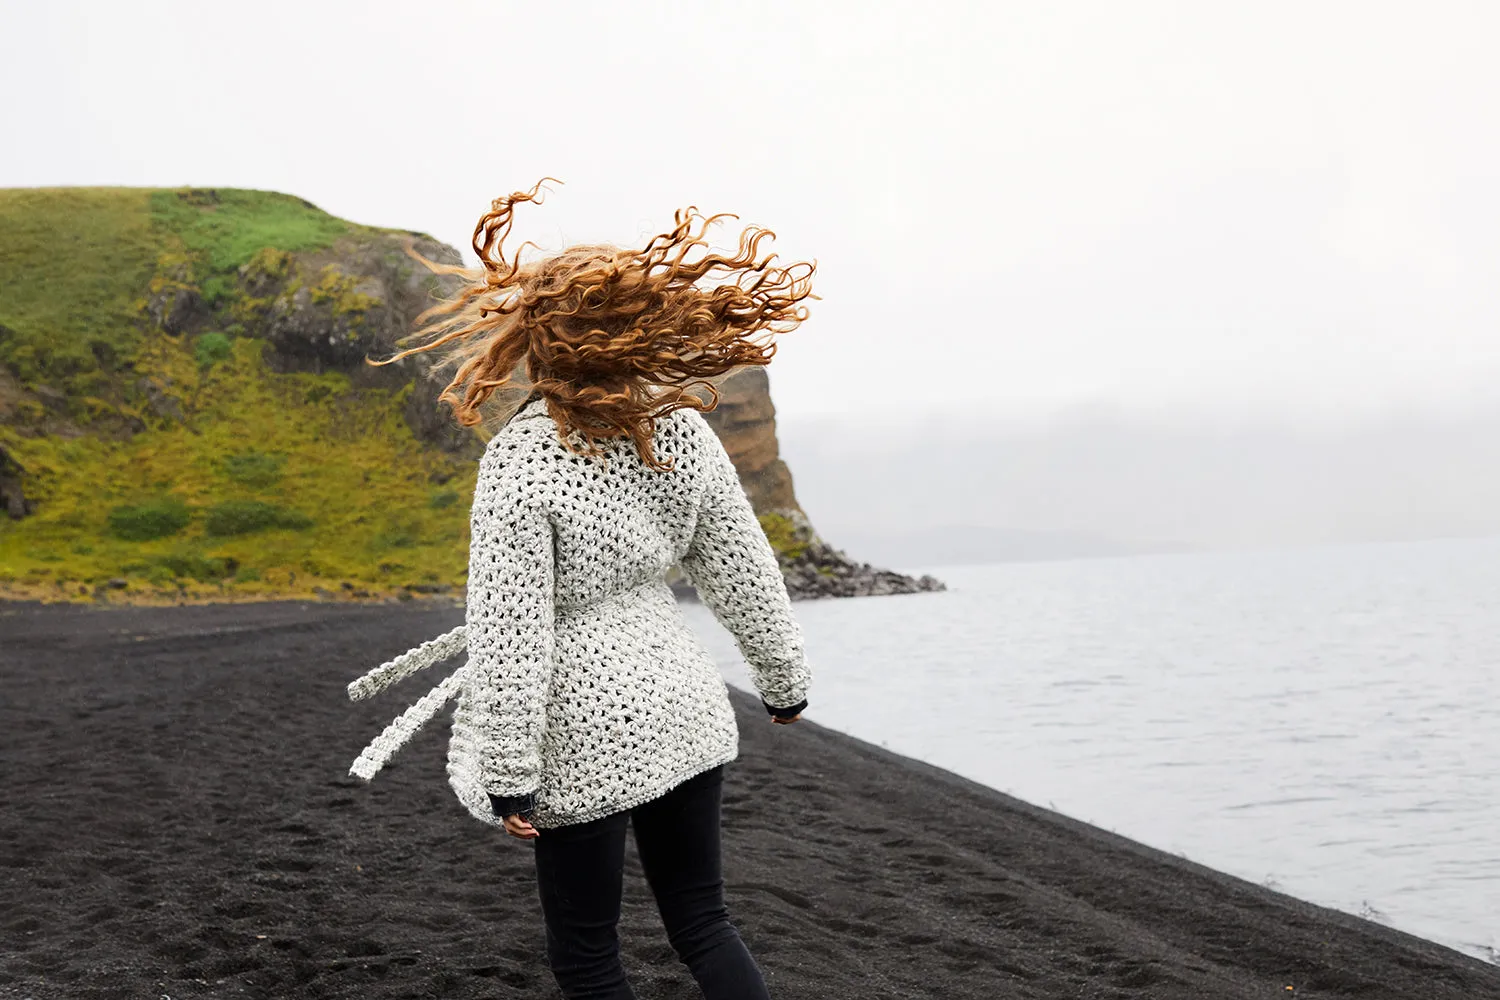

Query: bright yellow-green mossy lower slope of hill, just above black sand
0;339;473;600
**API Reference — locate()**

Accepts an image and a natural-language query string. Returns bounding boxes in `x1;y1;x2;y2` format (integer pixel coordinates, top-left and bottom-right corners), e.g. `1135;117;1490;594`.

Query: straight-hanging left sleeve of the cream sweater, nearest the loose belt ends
465;445;555;798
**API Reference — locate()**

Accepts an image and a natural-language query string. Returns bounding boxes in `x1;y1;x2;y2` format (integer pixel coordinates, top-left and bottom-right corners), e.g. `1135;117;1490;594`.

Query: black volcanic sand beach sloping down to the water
0;603;1500;1000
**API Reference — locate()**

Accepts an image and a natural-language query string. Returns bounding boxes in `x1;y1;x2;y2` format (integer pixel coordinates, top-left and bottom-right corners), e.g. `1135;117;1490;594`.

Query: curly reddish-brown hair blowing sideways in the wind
371;178;816;471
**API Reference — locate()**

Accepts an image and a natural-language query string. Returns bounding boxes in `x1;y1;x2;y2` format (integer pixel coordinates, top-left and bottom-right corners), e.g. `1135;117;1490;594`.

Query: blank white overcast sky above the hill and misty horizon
0;0;1500;420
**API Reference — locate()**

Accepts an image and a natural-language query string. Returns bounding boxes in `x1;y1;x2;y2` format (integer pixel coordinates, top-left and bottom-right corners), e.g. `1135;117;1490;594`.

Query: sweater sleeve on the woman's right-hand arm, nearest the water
683;414;812;714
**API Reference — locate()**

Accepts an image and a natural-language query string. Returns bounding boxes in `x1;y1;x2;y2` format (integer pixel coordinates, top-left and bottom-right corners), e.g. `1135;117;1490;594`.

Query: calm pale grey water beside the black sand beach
687;538;1500;961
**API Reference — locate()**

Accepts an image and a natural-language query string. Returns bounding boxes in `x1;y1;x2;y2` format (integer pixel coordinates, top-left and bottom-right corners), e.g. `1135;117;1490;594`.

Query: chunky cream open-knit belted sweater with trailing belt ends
350;399;810;828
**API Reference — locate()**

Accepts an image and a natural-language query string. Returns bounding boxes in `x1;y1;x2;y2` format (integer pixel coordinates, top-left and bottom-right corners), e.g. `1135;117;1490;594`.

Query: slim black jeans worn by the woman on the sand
533;765;770;1000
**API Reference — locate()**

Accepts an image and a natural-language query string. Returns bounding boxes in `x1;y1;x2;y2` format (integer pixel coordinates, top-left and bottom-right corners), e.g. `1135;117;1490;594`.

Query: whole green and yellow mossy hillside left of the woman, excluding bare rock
0;189;471;601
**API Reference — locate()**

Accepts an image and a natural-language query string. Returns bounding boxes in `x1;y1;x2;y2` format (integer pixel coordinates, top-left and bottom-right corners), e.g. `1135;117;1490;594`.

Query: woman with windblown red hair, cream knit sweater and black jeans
350;184;813;1000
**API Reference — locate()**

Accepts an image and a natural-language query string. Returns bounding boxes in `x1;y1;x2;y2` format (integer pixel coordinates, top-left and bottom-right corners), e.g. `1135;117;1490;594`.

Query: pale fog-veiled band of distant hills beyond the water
780;408;1500;554
